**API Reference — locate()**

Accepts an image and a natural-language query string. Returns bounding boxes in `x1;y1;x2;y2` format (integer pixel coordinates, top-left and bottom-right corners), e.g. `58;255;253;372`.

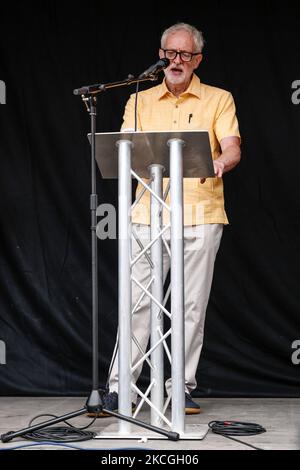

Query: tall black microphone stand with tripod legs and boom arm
0;74;179;442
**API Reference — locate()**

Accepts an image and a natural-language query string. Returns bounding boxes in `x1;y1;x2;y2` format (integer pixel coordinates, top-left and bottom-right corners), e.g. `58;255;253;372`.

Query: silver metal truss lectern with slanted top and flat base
92;131;214;439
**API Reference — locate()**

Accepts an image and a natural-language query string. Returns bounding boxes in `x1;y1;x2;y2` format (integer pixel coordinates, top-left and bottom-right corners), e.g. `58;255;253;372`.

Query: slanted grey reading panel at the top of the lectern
88;130;215;178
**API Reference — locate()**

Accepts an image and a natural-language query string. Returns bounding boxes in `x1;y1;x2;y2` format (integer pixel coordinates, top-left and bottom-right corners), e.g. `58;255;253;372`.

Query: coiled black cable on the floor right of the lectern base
208;421;266;450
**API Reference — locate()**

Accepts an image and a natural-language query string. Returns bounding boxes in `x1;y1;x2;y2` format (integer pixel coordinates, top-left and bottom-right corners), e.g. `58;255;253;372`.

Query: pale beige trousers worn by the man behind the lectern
109;224;223;400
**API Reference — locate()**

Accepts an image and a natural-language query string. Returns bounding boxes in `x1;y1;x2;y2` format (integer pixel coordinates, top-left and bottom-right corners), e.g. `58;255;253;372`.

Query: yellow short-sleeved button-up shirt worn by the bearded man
122;74;240;225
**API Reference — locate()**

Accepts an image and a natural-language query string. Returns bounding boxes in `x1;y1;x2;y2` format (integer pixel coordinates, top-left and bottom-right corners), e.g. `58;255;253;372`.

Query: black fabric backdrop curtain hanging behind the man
0;0;300;396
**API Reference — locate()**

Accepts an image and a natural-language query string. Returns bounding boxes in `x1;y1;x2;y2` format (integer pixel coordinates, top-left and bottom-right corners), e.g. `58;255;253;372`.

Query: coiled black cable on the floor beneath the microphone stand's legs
23;414;96;442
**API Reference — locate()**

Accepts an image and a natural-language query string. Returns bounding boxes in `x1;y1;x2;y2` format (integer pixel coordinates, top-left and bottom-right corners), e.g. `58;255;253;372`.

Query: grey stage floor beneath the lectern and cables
0;397;300;451
